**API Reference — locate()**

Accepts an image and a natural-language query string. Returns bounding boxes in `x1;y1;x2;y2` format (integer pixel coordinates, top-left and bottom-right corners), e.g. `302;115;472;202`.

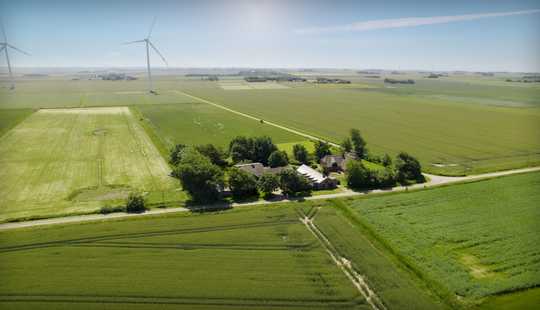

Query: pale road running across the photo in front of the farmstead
0;167;540;230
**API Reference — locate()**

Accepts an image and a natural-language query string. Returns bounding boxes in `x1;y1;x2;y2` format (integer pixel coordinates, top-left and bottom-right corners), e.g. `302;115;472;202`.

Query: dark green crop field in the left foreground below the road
0;207;370;309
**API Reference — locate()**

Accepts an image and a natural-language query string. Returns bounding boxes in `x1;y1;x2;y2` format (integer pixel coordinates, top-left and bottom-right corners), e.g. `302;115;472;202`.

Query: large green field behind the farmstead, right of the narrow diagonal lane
179;81;540;175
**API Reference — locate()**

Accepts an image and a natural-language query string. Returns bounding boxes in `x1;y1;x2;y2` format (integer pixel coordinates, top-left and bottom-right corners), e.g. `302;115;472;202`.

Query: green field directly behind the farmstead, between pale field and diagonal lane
136;102;305;147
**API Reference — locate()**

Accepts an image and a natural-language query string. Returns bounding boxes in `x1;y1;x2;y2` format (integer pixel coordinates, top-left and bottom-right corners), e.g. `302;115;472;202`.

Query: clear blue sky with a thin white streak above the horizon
0;0;540;72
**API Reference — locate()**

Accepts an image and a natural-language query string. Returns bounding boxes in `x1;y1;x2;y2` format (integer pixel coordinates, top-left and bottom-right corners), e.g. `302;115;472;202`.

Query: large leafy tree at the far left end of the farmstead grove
174;148;224;202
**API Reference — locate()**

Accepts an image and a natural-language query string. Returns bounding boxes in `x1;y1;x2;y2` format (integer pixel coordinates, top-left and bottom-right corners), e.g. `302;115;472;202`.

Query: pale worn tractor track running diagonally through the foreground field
299;207;387;310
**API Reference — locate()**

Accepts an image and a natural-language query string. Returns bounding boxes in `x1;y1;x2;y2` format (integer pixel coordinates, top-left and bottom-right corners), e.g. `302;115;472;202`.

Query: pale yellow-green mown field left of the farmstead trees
0;107;180;221
